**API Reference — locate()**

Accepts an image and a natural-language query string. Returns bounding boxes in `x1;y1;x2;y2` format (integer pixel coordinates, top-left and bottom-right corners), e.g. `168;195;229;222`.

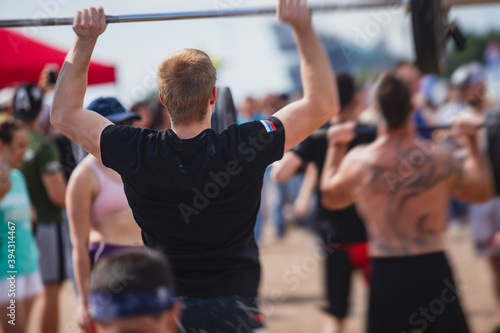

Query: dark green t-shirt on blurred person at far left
21;130;63;223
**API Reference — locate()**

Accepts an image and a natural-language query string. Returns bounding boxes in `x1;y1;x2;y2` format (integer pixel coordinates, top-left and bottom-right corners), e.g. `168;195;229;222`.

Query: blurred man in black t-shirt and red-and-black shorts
271;73;375;333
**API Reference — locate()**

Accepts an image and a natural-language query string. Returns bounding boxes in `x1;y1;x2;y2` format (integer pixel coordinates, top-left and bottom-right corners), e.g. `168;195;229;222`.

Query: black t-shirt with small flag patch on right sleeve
101;118;285;298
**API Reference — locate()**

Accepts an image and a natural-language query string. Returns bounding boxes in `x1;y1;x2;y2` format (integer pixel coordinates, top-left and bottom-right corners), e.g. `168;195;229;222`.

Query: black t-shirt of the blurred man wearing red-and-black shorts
291;125;375;244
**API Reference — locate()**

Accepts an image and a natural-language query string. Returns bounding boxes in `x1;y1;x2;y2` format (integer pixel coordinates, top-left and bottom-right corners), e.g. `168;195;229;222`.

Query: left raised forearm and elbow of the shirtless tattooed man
320;123;357;209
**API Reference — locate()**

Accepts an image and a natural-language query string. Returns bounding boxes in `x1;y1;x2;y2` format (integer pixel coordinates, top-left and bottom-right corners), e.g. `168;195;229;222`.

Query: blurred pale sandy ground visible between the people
28;220;500;333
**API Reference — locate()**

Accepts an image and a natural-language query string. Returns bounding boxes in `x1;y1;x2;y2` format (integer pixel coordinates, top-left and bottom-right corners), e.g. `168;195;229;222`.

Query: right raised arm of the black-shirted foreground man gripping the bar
274;0;339;151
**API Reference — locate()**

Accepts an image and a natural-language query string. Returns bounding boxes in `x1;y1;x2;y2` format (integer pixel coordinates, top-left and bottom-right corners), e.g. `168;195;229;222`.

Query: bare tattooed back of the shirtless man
351;138;462;257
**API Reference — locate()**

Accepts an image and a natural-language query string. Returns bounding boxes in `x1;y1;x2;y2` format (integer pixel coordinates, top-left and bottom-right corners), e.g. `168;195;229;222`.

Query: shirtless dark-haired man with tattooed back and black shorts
321;75;493;333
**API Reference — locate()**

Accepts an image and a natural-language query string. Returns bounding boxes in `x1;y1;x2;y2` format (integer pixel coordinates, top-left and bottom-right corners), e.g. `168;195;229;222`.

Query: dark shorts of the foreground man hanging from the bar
179;296;264;333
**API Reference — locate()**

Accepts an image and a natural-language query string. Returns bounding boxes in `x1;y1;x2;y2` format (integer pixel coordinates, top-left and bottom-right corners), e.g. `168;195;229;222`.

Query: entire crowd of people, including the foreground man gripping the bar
0;1;500;333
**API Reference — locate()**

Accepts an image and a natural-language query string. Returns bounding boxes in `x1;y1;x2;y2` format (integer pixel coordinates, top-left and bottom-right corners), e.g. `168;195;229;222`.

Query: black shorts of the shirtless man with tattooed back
368;252;469;333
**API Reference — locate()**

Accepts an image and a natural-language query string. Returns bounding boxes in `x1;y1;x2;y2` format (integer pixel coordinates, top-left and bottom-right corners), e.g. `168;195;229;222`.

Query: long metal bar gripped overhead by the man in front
0;0;398;28
